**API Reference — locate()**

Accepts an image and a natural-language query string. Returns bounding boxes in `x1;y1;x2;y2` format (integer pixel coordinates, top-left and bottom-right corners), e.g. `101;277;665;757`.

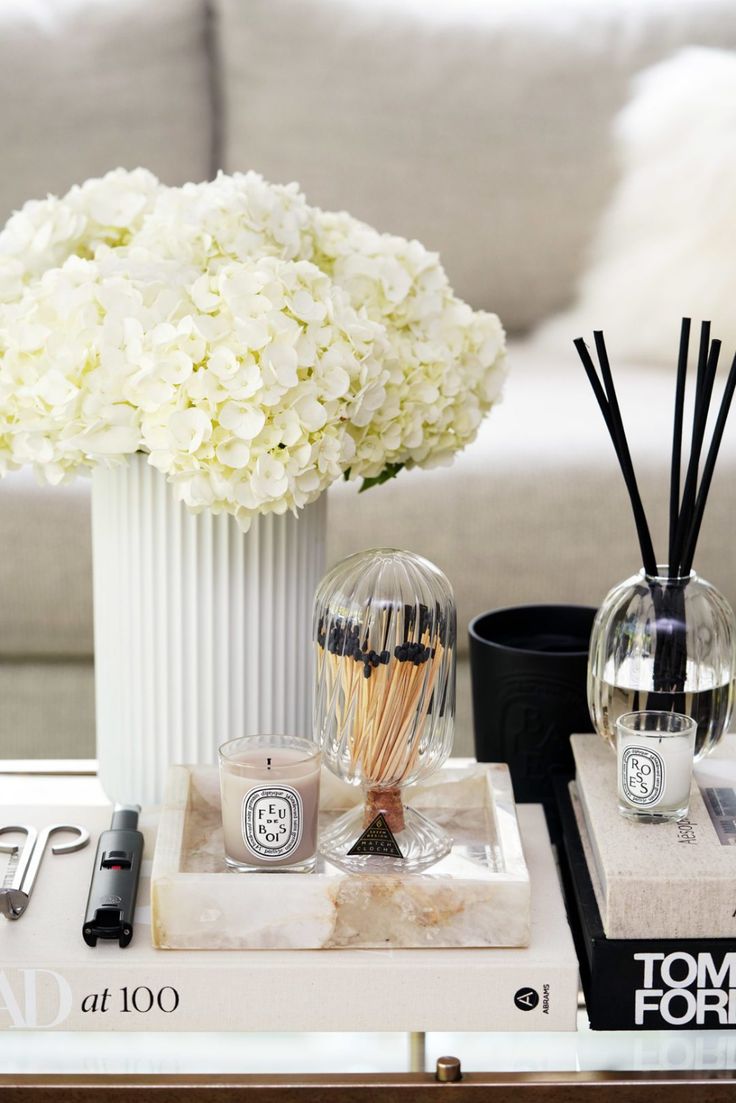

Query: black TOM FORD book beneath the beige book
556;779;736;1030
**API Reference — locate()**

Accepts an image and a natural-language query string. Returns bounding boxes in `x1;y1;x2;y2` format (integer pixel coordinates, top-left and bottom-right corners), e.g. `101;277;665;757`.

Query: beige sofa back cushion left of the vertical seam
0;0;213;223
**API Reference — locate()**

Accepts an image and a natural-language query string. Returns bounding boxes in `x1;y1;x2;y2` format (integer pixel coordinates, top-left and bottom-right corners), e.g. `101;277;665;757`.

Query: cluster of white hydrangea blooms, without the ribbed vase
0;169;504;529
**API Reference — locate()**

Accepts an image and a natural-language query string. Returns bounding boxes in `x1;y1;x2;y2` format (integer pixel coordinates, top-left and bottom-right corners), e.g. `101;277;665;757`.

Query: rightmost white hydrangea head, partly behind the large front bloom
314;211;505;478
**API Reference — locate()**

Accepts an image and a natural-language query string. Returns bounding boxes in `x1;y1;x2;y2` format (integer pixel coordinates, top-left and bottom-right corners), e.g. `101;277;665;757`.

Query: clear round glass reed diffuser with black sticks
575;318;736;758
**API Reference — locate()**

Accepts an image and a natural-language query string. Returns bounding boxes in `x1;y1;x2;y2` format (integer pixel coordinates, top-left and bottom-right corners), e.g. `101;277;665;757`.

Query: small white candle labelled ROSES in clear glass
616;710;697;823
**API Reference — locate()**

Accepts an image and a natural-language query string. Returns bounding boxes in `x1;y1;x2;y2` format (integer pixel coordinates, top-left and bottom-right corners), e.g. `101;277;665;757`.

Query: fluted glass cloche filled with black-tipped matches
314;549;457;872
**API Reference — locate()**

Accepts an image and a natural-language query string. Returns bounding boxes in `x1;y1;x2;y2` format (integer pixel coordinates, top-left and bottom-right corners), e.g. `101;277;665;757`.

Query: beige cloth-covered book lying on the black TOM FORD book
572;736;736;939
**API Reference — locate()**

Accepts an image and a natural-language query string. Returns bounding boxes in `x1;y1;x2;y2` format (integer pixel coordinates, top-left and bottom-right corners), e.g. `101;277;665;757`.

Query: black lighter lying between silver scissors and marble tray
82;804;143;946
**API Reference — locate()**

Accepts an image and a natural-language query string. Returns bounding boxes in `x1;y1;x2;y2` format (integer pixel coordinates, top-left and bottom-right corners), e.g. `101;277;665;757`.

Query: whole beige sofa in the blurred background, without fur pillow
0;0;736;758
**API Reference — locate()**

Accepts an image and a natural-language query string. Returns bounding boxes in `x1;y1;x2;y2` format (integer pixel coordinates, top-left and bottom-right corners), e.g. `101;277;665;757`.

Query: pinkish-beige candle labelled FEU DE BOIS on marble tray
220;736;321;872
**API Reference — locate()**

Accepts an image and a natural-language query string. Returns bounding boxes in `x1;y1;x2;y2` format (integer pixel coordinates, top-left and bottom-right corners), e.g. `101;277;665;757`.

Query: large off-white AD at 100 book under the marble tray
0;805;578;1031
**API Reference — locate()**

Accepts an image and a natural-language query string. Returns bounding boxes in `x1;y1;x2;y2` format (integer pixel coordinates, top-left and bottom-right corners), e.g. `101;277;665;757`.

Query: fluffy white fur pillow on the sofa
548;47;736;363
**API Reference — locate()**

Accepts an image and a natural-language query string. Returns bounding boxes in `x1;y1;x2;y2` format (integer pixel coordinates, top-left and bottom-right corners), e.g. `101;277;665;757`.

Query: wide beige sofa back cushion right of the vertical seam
215;0;736;331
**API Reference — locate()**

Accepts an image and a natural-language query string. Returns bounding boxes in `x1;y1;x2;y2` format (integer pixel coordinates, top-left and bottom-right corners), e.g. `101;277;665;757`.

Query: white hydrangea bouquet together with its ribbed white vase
0;169;504;803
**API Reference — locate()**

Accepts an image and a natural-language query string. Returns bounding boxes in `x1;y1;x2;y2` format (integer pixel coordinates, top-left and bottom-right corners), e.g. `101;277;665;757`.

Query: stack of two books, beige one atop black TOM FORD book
557;736;736;1030
